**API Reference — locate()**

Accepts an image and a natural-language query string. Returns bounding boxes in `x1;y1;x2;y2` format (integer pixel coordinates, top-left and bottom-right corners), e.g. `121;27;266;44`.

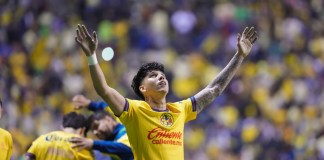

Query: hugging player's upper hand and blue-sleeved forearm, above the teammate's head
72;95;108;112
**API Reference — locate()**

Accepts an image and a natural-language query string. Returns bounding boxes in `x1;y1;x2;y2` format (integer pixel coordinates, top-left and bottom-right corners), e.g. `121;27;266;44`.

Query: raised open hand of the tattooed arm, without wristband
237;27;258;57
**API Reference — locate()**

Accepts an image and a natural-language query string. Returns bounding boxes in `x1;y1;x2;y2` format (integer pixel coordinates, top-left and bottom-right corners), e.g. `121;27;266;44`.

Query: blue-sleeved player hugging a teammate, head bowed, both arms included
72;95;134;160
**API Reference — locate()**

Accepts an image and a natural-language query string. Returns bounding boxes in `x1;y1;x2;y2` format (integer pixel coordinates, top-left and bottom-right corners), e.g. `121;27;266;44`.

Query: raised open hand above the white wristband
75;24;98;56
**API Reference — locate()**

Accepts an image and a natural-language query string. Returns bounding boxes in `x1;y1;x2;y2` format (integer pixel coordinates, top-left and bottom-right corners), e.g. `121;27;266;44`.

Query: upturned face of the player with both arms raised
140;70;169;95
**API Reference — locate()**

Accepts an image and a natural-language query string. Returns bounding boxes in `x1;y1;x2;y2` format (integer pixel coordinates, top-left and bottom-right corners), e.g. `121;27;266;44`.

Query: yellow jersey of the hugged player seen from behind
26;131;94;160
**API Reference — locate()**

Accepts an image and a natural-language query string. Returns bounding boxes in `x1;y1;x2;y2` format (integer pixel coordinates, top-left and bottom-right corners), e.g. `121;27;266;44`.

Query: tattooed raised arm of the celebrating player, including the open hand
194;27;258;113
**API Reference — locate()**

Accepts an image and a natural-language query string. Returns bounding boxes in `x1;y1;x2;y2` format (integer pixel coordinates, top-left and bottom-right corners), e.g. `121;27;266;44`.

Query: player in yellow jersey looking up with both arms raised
75;25;257;160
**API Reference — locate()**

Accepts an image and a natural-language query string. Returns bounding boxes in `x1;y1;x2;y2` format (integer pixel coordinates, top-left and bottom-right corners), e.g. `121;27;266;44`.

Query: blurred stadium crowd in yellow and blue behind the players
0;0;324;160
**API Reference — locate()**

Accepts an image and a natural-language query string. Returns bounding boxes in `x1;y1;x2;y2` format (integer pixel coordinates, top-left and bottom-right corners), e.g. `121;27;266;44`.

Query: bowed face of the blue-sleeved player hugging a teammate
91;116;114;139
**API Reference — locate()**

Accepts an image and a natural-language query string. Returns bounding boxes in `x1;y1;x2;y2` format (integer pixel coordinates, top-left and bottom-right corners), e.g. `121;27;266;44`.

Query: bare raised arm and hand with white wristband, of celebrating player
75;25;126;116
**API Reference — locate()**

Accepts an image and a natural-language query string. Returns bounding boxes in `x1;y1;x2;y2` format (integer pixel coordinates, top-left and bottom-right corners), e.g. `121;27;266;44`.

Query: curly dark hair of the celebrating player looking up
132;62;164;100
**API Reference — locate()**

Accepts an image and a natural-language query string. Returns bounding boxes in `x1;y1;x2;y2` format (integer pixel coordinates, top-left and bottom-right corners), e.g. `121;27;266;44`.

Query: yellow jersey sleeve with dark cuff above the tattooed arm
179;97;197;122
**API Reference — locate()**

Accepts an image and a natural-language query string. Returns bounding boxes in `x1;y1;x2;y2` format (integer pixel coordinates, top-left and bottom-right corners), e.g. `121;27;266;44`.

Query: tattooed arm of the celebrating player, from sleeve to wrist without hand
195;52;244;113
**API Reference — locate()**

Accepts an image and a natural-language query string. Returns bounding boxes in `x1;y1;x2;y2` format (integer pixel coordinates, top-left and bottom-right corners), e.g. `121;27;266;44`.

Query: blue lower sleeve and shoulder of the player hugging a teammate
93;123;134;160
